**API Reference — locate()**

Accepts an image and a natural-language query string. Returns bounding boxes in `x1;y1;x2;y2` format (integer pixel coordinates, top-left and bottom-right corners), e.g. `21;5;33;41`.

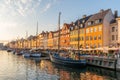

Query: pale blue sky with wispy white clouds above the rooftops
0;0;120;41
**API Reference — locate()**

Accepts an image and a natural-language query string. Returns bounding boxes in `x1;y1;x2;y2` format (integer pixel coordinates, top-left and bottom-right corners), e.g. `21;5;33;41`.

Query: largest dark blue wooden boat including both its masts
50;13;86;67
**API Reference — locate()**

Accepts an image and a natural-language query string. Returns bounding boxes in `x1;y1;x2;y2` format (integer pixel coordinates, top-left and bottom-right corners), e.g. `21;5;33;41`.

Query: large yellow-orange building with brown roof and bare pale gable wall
85;9;114;48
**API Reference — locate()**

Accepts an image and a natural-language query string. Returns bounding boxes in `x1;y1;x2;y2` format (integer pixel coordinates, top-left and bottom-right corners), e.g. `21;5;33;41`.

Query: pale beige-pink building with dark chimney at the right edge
109;11;120;47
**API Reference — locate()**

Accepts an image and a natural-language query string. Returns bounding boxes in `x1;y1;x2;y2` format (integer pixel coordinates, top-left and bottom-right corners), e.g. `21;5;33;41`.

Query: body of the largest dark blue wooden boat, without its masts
50;53;86;67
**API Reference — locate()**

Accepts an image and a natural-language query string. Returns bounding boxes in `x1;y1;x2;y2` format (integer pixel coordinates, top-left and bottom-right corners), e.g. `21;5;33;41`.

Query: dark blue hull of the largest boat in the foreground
50;55;86;68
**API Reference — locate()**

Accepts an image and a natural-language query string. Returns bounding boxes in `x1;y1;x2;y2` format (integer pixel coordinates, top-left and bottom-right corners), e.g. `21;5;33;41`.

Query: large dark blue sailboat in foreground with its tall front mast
49;13;86;67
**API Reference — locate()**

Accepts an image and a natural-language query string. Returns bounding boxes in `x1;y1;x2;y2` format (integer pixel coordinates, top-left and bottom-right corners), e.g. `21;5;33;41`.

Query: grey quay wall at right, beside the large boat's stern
86;56;120;71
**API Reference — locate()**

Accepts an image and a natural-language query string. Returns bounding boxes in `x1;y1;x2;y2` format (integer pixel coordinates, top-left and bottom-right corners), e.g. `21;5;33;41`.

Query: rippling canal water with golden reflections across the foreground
0;51;120;80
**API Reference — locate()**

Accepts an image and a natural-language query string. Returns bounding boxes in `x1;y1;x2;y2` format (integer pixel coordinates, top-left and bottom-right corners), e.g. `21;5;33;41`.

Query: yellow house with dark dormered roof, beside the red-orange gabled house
70;15;91;49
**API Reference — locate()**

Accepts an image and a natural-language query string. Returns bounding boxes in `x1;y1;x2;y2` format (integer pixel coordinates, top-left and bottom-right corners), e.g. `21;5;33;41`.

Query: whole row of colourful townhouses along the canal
9;9;120;49
